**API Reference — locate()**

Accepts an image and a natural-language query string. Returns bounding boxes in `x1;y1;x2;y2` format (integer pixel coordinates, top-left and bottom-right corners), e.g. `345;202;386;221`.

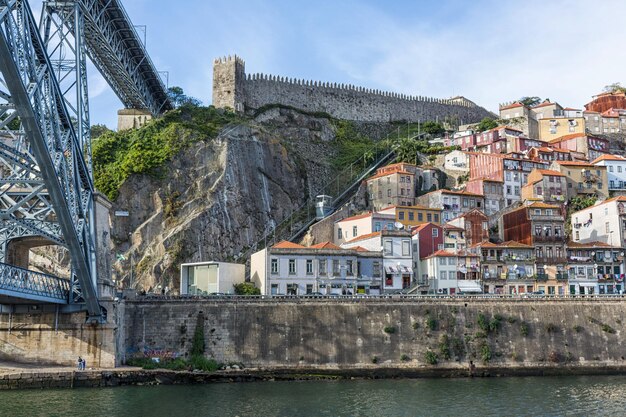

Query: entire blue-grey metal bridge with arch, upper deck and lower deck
0;0;171;321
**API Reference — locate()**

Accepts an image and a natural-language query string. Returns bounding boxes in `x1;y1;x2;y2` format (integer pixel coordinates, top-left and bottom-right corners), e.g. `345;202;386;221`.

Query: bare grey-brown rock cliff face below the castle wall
112;109;334;291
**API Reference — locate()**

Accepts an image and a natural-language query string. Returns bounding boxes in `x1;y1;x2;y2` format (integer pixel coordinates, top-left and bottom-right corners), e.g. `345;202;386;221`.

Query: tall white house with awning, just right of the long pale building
341;230;413;292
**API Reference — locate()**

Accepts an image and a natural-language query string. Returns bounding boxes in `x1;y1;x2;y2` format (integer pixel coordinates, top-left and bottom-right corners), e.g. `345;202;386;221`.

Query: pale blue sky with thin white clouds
31;0;626;128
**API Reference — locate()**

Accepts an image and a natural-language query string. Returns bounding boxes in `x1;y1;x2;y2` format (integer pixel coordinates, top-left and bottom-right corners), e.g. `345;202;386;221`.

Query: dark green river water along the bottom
0;376;626;417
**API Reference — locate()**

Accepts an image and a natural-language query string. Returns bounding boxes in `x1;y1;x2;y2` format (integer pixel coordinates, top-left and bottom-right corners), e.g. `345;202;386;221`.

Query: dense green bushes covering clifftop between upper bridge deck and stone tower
92;105;238;200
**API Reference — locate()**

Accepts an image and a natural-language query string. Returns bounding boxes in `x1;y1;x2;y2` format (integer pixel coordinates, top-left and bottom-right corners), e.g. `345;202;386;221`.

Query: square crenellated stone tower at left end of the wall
213;55;246;112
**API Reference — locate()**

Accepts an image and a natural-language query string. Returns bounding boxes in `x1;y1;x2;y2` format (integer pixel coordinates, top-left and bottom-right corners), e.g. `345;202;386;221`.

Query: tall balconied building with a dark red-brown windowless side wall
500;202;567;294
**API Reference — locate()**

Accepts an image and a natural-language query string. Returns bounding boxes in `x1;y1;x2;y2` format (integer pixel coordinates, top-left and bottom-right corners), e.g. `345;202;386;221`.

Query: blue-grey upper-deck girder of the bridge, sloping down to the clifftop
45;0;172;116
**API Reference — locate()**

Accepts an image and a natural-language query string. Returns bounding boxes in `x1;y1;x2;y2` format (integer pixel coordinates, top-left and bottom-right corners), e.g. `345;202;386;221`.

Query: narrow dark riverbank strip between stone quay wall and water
0;363;626;390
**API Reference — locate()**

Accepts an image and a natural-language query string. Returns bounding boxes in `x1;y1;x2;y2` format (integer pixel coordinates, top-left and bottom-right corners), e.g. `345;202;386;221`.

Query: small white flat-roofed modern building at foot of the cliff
180;261;246;295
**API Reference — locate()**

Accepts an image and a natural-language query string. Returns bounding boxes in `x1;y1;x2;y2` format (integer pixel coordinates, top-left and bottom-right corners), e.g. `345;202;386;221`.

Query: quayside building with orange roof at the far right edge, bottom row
567;242;624;294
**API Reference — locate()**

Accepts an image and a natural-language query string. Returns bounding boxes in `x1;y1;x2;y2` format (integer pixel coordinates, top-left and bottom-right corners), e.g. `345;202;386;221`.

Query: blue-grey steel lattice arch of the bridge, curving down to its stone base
0;0;103;320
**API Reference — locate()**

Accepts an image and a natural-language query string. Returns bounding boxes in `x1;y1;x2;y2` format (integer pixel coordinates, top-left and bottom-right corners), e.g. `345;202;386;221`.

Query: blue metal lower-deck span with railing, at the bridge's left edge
0;263;70;304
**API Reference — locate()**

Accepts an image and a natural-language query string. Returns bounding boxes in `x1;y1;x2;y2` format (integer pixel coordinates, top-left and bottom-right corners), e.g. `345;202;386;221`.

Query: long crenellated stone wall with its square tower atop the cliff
213;56;495;123
